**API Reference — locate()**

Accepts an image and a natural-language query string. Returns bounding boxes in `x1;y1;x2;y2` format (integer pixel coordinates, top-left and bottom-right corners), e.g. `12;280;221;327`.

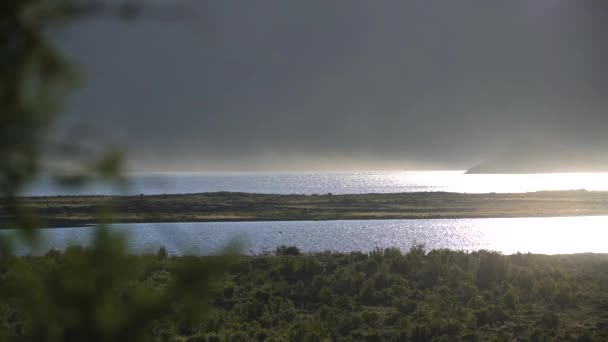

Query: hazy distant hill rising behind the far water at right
466;141;608;174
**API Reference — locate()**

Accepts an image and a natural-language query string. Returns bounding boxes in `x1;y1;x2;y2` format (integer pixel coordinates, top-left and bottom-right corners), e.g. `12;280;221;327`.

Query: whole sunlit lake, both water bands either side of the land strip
17;171;608;254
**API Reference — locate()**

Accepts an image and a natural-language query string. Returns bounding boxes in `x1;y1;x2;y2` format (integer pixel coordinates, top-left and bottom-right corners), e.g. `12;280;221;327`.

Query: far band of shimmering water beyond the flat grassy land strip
19;171;608;196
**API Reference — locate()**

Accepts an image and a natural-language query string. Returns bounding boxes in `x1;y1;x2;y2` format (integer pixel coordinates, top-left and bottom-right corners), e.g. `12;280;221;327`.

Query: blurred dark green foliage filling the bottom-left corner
0;229;235;341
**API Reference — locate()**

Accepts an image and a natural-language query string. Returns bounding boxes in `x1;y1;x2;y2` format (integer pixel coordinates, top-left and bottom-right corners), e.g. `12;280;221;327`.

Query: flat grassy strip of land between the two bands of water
0;190;608;228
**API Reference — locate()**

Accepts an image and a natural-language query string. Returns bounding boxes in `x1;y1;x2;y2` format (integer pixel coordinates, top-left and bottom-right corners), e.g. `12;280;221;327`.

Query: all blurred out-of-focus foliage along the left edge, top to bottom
0;0;233;341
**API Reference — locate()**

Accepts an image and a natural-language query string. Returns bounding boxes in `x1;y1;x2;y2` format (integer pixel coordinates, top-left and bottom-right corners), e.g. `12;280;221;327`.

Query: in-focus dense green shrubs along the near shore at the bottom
0;247;608;341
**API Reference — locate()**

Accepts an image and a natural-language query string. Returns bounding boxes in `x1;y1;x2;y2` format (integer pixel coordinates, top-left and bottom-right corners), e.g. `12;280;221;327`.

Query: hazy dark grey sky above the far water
55;0;608;171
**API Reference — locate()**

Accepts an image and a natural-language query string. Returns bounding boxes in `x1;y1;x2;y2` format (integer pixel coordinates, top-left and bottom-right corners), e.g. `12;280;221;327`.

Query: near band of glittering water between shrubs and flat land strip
9;216;608;254
